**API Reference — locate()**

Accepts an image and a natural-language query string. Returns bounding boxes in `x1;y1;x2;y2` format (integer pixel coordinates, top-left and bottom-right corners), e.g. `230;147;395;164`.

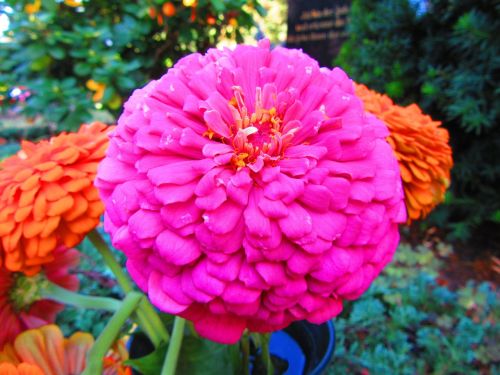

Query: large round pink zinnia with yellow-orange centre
96;42;405;343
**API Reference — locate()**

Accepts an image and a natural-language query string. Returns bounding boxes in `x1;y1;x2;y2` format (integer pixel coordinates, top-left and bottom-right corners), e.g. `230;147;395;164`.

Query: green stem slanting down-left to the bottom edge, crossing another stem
83;292;143;375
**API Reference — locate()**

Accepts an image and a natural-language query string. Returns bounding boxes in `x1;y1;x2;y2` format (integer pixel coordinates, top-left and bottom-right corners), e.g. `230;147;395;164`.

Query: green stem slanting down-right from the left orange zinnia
88;229;169;347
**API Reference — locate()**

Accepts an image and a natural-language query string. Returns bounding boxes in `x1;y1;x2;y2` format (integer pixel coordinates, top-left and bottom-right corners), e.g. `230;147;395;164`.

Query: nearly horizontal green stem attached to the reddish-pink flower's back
41;281;122;311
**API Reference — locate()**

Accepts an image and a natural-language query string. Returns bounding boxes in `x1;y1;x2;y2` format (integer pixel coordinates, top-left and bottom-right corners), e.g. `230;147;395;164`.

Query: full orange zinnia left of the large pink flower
0;122;111;274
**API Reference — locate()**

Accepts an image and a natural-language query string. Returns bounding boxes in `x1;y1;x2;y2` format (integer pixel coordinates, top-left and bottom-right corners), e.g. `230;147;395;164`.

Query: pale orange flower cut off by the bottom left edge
0;324;132;375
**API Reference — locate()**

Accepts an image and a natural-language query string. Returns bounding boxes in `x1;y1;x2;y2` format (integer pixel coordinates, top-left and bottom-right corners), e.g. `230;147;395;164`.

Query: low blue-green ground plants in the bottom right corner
328;245;500;375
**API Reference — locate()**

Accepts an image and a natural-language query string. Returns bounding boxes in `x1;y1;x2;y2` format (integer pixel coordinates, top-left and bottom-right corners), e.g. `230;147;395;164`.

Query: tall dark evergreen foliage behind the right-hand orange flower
336;0;500;237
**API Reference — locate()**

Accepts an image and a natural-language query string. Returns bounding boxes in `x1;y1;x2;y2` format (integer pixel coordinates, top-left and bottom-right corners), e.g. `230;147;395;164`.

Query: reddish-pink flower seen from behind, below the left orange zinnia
0;246;79;350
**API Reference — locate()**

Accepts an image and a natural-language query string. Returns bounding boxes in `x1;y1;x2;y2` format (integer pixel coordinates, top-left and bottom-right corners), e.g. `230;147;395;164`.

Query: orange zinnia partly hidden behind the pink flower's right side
355;84;453;222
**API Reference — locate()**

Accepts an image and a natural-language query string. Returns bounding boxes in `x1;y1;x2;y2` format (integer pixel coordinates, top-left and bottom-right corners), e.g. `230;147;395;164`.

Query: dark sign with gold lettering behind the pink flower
286;0;351;67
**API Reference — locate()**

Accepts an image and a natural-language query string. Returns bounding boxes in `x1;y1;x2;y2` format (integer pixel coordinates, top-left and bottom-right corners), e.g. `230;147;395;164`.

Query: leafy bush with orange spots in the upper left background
0;0;263;130
